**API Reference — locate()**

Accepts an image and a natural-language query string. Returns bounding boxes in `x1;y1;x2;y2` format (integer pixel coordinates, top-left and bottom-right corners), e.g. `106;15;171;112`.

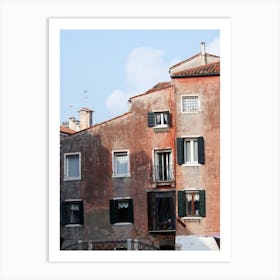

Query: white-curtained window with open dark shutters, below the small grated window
176;137;205;165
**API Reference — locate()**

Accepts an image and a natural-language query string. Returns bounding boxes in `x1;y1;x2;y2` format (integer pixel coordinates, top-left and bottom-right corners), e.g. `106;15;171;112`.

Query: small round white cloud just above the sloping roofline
106;89;129;115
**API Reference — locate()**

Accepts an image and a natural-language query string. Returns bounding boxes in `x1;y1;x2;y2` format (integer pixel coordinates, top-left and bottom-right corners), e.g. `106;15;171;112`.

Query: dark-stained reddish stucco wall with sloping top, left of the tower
61;84;175;246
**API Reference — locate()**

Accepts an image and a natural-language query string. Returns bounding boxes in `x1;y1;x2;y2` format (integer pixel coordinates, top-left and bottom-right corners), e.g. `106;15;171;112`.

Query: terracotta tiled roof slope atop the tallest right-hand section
171;61;220;78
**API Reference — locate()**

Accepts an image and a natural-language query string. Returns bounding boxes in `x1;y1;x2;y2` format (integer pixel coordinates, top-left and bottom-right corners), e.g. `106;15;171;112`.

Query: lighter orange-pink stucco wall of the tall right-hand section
174;76;220;235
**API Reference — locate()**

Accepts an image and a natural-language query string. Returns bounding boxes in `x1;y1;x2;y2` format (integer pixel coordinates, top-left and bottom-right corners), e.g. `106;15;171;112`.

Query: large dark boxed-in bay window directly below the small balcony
148;191;176;232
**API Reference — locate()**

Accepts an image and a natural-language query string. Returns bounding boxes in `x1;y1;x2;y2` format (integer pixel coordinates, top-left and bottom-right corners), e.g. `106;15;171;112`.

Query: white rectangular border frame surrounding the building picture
49;18;231;262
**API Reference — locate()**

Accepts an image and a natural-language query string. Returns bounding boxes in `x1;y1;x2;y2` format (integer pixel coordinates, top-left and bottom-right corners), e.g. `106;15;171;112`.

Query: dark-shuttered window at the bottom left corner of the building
62;200;84;225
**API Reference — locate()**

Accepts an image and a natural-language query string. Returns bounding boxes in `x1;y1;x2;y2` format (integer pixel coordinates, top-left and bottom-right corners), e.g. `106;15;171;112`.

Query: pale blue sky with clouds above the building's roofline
60;30;220;124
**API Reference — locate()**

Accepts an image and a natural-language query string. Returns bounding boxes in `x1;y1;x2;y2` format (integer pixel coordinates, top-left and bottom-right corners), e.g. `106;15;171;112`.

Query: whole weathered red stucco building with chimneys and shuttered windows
60;44;220;250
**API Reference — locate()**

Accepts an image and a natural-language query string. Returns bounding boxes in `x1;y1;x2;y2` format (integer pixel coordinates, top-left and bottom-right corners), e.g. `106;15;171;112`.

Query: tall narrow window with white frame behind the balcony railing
153;150;173;182
